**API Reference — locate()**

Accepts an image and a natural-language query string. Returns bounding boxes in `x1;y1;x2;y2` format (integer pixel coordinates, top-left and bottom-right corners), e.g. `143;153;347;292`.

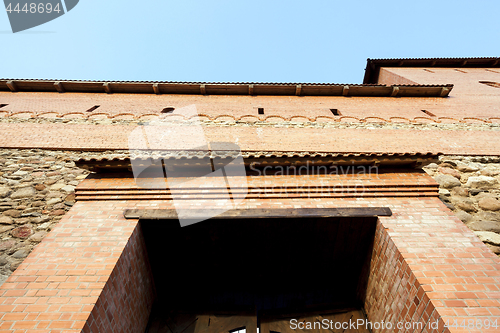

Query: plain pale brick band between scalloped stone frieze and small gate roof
0;123;500;155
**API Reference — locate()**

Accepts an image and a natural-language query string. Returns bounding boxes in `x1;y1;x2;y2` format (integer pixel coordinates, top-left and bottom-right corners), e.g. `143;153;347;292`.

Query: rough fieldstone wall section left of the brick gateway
0;149;92;285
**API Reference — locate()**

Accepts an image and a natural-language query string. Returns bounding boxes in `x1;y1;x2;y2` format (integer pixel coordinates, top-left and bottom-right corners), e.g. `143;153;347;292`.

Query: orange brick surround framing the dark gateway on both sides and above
0;170;500;332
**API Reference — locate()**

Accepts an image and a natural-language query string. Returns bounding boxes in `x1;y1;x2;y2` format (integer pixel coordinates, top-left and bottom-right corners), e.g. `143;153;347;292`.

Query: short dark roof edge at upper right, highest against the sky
363;57;500;84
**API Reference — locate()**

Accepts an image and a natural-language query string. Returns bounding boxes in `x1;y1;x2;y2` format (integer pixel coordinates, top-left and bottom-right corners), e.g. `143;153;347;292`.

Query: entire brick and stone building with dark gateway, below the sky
0;58;500;333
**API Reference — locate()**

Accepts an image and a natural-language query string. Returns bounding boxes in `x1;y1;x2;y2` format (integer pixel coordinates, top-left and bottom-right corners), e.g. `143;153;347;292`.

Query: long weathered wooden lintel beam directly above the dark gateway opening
123;207;392;220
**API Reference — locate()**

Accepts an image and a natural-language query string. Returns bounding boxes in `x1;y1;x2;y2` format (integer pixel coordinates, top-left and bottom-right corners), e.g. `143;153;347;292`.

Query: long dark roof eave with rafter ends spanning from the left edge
0;79;453;97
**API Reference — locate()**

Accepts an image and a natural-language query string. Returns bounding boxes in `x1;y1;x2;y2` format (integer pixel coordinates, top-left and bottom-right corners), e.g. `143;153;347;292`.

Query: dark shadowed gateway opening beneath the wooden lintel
134;208;390;333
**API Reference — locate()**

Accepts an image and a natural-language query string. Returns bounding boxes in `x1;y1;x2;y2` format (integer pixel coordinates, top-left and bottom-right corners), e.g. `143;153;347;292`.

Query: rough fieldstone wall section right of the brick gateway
424;156;500;255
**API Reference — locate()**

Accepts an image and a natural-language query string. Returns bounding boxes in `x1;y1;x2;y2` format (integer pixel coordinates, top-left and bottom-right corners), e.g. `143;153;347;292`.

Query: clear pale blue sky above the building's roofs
0;0;500;83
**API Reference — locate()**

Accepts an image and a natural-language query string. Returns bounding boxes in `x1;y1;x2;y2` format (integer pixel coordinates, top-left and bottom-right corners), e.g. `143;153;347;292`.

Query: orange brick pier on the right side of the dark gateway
365;193;500;332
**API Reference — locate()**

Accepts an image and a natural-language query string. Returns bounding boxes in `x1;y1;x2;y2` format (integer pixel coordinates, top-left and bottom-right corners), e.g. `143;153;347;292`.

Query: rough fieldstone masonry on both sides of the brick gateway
0;149;500;285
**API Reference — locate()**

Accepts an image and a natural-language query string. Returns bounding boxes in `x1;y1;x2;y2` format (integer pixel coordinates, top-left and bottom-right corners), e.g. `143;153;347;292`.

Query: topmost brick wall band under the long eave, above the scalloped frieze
0;78;500;122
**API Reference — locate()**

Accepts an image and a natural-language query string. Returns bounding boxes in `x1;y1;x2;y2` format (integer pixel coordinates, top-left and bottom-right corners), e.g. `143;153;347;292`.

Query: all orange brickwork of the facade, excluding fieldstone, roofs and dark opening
0;63;500;333
